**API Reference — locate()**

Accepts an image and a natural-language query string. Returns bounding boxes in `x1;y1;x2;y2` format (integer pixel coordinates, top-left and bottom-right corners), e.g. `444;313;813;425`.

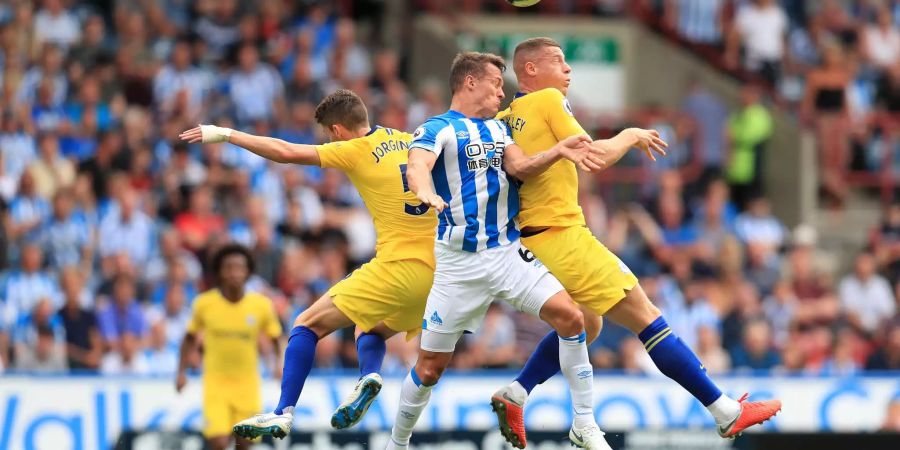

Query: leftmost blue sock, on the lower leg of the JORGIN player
275;326;319;414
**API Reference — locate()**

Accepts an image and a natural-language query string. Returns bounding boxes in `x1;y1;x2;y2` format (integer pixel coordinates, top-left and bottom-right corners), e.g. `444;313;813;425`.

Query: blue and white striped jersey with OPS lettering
410;110;519;252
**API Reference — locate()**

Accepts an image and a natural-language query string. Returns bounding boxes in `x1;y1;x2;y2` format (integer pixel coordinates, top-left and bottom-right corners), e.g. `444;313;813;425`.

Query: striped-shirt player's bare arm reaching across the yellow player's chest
503;134;603;180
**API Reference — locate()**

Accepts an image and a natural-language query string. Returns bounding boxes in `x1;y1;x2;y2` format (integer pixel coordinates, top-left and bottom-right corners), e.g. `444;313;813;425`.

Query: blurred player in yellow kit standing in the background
175;244;281;450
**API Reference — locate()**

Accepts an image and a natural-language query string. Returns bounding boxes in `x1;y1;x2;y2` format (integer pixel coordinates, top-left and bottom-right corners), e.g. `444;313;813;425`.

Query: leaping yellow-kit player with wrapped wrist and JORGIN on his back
181;90;437;438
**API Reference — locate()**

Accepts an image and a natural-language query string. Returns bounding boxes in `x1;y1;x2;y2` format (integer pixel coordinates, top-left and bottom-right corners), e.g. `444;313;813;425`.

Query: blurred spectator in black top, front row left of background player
58;268;103;371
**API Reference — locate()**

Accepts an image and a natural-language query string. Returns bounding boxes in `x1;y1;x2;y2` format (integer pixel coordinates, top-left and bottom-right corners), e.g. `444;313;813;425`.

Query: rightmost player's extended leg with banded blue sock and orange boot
606;286;781;437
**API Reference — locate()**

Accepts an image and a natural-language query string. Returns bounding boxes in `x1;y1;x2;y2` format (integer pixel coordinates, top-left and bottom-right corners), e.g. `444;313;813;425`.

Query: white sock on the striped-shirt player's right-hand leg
559;333;595;428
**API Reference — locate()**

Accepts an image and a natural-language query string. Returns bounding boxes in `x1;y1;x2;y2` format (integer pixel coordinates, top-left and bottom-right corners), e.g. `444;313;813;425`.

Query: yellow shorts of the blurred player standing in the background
203;379;262;438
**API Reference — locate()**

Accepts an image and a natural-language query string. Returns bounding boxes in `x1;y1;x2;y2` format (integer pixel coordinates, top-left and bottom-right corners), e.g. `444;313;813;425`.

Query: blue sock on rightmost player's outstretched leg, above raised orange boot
638;316;722;406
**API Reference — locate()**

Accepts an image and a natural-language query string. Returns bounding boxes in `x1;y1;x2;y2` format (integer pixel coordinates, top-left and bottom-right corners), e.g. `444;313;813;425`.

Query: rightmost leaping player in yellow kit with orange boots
491;37;781;448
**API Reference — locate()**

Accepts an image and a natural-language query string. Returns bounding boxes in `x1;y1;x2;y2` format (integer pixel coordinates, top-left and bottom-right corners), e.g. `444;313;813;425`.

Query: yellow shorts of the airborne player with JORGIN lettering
328;257;434;339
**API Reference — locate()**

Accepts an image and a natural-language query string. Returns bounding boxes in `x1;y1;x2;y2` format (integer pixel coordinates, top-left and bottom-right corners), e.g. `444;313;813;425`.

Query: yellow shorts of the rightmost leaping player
522;226;638;315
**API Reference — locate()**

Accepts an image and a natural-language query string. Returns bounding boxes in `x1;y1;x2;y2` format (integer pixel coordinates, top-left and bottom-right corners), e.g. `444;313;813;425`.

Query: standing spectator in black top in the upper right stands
801;44;852;206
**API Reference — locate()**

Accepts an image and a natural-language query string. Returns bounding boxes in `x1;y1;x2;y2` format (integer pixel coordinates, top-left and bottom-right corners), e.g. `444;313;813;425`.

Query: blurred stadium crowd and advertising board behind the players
0;0;900;450
